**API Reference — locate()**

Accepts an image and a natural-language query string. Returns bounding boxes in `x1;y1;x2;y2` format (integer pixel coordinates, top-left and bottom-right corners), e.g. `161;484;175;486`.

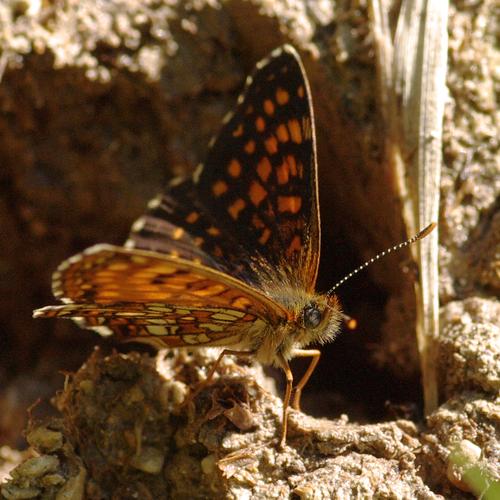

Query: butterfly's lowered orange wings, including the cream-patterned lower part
34;245;287;346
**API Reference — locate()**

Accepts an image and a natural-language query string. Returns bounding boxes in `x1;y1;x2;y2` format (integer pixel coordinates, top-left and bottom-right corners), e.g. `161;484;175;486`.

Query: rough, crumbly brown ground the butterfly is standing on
1;349;440;499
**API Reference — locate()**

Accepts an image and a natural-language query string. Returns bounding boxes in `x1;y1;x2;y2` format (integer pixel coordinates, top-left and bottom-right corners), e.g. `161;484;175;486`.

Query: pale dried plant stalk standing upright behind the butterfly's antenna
371;0;448;414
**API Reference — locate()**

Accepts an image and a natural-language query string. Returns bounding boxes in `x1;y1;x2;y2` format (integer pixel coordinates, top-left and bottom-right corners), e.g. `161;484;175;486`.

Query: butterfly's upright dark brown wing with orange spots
127;46;320;290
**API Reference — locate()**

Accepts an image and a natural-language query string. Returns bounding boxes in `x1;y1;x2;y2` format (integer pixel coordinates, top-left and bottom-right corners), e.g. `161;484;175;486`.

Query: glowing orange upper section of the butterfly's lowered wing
46;245;284;322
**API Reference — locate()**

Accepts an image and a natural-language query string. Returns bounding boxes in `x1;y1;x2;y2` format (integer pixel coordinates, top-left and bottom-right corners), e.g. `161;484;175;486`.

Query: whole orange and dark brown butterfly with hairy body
34;45;434;446
